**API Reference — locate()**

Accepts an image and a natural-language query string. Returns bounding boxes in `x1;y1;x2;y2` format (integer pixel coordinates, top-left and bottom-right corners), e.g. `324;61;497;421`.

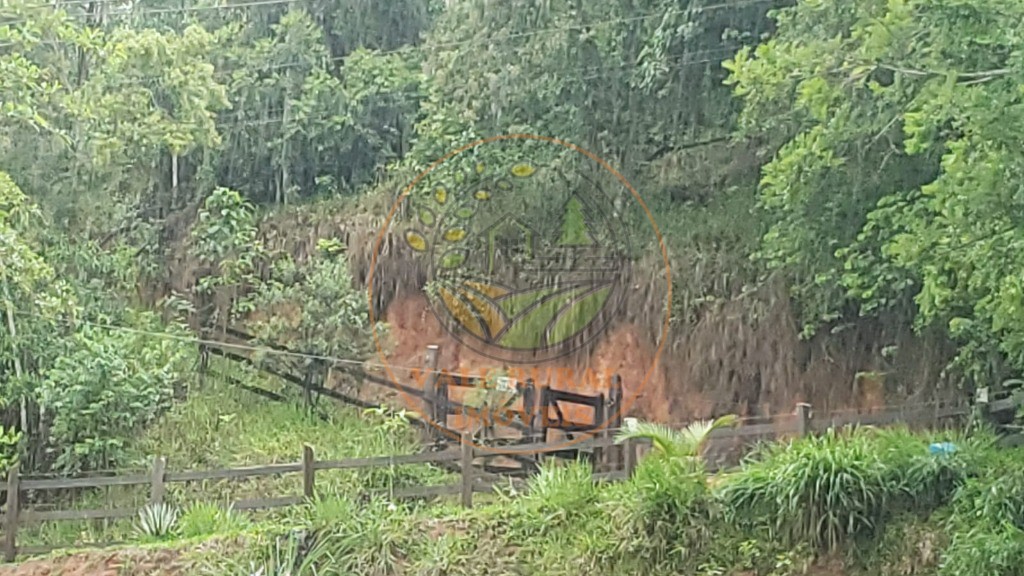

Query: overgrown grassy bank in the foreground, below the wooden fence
8;420;1024;576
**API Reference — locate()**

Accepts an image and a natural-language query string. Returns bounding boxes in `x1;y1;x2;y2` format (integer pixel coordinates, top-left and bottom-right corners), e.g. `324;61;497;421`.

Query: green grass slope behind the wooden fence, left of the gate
18;358;453;546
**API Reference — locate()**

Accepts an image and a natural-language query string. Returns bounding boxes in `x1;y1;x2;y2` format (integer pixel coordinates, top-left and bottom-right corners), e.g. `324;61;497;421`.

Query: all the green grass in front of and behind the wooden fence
14;383;1024;576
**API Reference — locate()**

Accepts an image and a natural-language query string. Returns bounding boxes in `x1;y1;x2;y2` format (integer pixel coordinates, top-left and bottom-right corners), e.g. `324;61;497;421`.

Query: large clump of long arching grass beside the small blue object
721;427;967;551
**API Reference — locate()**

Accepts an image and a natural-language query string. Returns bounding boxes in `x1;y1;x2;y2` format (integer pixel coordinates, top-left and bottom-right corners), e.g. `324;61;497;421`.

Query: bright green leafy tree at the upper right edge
728;0;1024;381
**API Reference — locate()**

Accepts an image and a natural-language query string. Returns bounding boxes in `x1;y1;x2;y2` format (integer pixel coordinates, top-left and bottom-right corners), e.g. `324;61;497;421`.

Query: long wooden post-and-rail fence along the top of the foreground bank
0;404;966;562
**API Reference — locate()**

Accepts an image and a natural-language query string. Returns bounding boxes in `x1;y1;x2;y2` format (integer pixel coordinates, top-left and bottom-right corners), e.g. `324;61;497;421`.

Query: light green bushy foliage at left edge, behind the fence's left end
0;174;193;472
